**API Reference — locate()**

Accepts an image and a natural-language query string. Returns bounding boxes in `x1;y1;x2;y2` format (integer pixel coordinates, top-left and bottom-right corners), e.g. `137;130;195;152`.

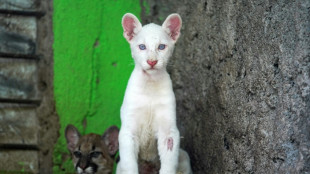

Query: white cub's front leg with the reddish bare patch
157;108;180;174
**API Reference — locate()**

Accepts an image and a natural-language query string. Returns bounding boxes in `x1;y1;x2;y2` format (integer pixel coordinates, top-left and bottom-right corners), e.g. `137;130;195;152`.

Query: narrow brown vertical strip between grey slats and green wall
36;0;60;174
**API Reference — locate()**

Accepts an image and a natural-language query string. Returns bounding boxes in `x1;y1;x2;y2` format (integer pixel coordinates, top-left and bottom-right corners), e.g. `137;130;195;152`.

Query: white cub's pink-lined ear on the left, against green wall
122;13;142;42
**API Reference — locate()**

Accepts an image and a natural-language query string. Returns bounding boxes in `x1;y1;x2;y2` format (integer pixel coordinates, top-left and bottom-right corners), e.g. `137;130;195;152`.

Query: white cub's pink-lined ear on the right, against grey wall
162;13;182;42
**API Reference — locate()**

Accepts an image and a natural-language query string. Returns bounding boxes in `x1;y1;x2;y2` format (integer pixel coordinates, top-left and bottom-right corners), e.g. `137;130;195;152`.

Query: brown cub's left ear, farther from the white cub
65;124;81;153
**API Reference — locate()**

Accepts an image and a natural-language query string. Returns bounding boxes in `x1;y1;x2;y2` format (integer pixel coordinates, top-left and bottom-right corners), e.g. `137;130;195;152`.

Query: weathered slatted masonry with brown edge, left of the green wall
0;0;58;173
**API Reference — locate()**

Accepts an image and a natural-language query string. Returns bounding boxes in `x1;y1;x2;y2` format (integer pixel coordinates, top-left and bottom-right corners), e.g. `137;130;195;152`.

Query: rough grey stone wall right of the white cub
141;0;310;174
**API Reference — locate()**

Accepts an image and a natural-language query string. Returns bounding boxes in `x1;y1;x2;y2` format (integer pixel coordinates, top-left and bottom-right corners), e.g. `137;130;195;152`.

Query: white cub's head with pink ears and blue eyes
122;13;182;74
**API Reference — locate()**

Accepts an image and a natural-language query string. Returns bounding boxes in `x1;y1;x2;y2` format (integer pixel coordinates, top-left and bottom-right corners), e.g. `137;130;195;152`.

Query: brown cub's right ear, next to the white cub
102;126;119;156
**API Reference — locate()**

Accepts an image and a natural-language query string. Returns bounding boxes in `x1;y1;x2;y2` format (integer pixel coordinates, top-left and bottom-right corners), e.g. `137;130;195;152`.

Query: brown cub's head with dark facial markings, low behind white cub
65;125;119;174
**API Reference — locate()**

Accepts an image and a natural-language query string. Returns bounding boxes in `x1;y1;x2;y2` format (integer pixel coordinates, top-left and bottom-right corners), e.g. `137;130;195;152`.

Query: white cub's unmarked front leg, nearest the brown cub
116;124;139;174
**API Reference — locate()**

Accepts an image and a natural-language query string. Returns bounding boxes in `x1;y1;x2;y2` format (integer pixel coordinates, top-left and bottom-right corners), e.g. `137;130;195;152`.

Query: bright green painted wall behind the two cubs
53;0;141;173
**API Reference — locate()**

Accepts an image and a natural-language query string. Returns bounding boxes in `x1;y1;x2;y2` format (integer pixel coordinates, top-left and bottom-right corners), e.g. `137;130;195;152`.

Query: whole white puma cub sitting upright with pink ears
117;13;191;174
